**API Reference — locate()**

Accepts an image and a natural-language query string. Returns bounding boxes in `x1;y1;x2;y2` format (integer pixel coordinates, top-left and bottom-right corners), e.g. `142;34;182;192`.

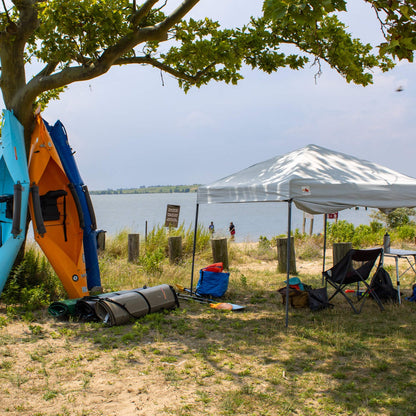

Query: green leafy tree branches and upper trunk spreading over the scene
0;0;416;144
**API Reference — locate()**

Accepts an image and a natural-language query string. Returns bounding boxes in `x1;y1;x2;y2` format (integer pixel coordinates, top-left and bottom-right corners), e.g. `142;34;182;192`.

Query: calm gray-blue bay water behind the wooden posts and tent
91;193;373;242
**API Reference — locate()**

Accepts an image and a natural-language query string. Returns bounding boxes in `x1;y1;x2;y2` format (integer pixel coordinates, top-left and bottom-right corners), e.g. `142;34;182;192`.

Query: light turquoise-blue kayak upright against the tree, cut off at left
0;110;29;293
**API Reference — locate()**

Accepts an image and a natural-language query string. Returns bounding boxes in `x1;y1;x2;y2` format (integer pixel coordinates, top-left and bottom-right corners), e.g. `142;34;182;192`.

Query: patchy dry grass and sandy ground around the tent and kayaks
0;245;416;416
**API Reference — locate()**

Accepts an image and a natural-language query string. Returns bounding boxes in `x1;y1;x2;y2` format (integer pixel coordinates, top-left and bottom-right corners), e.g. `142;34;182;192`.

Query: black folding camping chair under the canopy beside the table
323;248;384;313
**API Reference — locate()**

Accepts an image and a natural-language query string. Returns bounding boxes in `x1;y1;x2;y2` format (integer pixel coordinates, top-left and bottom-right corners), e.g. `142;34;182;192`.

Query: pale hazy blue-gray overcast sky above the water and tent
5;0;416;190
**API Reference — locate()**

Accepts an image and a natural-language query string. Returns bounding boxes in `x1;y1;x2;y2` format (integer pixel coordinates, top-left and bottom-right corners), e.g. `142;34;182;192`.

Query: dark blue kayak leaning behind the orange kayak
44;120;101;291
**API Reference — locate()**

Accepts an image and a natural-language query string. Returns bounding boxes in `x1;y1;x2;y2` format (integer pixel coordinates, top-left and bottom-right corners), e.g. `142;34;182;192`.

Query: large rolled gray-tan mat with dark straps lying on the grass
95;284;179;326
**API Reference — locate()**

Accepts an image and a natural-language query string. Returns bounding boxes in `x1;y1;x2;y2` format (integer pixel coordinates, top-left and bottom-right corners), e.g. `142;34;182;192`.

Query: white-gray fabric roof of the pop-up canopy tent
197;145;416;214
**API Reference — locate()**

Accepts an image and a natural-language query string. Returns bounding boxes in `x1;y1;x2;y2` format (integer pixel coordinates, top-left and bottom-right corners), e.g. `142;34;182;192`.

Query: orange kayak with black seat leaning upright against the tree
29;115;89;299
